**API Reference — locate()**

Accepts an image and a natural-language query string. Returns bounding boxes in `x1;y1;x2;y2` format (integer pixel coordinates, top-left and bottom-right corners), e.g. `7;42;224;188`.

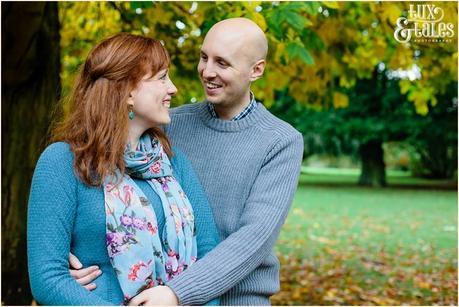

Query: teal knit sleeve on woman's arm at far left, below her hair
27;143;112;305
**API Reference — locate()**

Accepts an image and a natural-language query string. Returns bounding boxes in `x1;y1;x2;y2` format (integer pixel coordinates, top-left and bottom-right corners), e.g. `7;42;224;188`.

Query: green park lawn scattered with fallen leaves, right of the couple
273;170;458;305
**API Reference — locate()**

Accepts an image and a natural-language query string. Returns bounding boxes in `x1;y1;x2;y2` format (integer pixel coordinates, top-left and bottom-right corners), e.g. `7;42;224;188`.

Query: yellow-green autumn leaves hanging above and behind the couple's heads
59;1;457;114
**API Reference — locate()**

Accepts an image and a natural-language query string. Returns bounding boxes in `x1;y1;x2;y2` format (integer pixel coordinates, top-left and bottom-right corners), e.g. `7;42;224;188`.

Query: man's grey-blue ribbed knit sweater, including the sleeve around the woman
166;103;303;305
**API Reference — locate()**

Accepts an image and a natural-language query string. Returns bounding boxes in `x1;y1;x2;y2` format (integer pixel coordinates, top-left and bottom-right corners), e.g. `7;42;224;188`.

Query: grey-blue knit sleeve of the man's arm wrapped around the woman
169;133;303;305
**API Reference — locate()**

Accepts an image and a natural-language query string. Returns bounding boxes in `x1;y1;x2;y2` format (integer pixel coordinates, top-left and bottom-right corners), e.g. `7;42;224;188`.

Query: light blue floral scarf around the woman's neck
104;134;197;303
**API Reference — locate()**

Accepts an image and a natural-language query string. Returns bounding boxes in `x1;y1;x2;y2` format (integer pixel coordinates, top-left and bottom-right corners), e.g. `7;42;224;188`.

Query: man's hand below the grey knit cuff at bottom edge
129;286;178;306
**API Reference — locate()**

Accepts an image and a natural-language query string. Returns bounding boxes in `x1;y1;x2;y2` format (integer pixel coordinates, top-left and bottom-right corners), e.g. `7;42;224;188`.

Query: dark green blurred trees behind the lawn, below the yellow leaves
271;68;457;186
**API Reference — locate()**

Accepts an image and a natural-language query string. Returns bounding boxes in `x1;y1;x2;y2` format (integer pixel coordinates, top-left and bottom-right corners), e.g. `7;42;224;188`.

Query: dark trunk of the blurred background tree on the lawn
359;140;386;187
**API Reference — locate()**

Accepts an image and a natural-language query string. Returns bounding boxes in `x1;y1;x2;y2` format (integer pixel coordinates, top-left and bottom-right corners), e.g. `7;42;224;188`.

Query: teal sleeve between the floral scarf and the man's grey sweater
174;148;220;306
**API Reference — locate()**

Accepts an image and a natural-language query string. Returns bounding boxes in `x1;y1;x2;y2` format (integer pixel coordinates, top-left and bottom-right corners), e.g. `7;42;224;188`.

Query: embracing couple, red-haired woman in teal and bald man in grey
28;18;303;305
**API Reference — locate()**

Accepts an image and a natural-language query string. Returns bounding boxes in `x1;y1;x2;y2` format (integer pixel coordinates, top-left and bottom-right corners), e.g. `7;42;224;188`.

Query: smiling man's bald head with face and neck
198;18;268;115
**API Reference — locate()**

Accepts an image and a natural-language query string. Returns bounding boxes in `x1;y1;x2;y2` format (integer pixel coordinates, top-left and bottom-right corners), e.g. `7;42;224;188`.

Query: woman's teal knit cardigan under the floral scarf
27;142;219;305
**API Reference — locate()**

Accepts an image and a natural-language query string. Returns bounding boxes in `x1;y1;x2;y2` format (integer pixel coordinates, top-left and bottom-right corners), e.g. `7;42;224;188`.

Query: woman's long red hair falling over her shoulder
52;33;172;186
